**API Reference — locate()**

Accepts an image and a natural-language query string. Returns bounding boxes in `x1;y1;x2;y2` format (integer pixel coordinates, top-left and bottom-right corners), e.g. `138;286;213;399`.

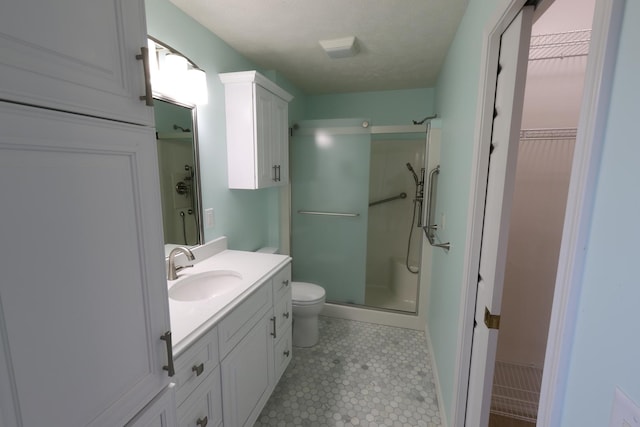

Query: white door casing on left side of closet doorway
451;0;525;426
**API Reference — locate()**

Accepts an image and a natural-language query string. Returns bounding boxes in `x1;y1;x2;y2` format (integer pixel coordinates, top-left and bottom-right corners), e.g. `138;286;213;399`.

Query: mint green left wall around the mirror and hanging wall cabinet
145;0;304;250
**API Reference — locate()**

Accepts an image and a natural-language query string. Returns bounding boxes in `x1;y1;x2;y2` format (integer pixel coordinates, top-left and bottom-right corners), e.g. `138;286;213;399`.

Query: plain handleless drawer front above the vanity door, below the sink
218;280;272;359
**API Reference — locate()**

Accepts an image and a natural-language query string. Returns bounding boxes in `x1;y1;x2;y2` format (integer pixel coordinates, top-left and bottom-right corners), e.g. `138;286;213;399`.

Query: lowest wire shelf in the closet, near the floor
491;362;542;423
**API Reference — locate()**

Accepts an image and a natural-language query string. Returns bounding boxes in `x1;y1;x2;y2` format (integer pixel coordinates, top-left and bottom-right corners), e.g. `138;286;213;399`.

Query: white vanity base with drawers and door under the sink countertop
174;262;292;427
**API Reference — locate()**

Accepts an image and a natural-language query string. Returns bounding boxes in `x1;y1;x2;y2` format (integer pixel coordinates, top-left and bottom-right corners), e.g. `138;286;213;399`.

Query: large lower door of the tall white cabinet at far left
0;102;169;427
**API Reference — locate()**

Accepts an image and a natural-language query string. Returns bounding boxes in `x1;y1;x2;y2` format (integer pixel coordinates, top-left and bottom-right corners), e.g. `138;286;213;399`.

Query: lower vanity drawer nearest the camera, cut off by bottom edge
178;366;222;427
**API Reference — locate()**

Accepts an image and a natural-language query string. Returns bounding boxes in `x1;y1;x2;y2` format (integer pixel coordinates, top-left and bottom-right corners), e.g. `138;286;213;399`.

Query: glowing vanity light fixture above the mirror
148;38;209;105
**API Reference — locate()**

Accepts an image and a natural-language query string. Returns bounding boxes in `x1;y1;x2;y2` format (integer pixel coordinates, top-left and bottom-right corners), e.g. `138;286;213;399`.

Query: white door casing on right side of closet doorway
538;0;624;426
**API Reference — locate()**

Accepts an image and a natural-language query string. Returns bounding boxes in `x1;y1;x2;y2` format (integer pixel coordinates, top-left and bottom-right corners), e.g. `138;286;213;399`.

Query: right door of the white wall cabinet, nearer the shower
271;95;289;185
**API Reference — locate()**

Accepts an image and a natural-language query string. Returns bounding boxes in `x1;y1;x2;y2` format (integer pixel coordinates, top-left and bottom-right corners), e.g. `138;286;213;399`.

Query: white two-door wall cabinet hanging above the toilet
220;71;293;189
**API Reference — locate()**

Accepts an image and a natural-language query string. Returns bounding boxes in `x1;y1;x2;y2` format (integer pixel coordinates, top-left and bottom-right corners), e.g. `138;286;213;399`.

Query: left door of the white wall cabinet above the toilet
254;85;277;188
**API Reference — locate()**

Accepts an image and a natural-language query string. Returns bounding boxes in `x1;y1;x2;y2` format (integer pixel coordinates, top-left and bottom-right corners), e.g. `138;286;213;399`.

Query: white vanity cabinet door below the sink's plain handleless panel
221;312;275;427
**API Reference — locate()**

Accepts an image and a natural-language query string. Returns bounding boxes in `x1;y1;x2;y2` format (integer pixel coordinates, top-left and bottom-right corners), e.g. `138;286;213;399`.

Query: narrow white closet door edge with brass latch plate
465;6;533;427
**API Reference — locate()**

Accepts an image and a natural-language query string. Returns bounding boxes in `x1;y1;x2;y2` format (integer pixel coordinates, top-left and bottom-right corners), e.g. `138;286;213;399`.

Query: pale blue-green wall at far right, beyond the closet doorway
562;0;640;426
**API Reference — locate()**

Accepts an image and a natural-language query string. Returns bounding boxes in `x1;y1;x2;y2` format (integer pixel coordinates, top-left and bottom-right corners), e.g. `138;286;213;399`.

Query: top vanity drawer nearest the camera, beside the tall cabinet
172;328;219;406
